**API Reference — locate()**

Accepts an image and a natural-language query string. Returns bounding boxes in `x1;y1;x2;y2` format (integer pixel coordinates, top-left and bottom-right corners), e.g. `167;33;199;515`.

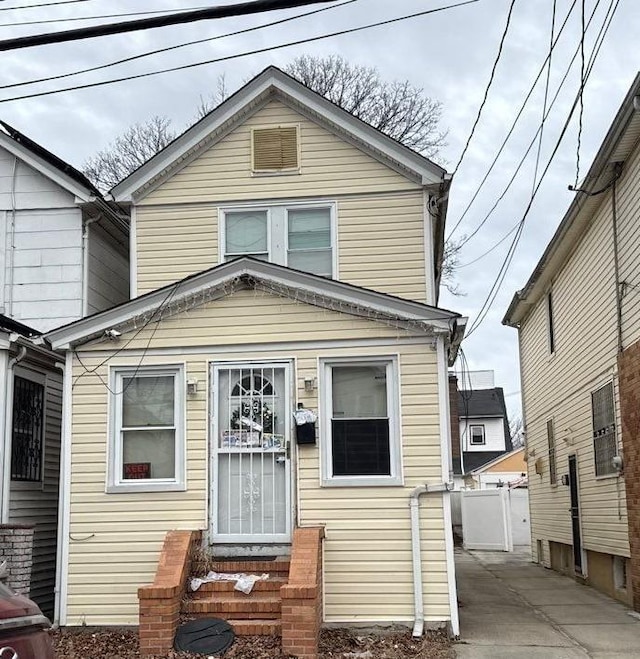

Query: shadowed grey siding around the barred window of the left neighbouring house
9;362;62;618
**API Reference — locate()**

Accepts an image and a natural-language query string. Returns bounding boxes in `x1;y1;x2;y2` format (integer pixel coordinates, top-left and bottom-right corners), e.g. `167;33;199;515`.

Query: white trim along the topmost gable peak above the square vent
111;66;447;202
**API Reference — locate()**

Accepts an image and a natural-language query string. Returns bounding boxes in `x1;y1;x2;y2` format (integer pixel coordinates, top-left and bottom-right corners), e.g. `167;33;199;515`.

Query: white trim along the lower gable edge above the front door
44;257;459;350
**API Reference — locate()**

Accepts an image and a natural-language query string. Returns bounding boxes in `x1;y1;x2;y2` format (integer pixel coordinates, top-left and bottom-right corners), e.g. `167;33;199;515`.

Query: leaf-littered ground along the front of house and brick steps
53;629;455;659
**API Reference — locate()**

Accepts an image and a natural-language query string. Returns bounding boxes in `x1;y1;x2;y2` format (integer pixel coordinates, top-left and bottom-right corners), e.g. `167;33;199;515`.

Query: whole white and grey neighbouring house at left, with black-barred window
0;122;129;615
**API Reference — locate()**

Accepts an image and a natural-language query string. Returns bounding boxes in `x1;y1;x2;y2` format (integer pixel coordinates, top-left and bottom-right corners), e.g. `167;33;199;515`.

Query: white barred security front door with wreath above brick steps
211;363;292;544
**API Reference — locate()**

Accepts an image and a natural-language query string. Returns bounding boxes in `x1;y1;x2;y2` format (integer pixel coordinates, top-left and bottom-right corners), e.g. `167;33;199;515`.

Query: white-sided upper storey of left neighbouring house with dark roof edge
0;121;129;332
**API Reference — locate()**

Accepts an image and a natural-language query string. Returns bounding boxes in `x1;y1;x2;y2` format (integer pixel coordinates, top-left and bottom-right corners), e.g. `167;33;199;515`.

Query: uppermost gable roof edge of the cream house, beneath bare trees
111;66;448;202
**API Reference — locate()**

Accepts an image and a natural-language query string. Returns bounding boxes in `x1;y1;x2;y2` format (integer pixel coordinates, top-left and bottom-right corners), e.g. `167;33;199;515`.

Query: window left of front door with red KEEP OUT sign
109;366;185;491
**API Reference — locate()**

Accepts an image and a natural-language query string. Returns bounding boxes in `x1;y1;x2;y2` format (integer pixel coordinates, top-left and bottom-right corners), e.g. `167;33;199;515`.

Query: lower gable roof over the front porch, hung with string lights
45;256;466;359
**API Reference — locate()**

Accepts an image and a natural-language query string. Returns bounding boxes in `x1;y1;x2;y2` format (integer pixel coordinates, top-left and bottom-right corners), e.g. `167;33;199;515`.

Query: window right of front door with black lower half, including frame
323;358;402;486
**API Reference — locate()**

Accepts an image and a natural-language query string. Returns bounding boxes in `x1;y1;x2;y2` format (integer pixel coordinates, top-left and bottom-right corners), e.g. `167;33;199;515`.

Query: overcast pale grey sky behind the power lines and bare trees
0;0;640;414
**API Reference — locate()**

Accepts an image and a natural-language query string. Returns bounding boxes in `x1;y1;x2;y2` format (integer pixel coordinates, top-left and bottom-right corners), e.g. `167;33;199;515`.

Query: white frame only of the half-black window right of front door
320;355;404;487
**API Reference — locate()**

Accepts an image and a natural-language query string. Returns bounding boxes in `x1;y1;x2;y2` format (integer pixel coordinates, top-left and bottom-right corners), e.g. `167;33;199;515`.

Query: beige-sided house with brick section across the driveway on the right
504;76;640;609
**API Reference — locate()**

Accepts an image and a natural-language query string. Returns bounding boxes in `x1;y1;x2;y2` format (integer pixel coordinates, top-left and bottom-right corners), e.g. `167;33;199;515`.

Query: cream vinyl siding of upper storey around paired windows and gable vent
136;96;428;302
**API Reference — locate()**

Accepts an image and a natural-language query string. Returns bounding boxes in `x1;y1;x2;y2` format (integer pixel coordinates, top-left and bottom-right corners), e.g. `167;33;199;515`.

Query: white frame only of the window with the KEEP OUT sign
106;364;187;493
